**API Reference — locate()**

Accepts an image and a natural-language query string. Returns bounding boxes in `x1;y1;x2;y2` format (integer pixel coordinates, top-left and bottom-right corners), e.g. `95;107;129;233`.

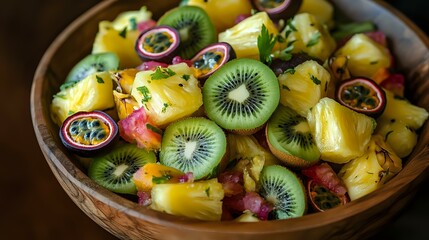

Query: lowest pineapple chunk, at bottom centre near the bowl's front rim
150;179;224;221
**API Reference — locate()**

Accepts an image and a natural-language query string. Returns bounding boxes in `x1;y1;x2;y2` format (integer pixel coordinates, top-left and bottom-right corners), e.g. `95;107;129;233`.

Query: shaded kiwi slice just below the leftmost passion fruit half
88;144;156;194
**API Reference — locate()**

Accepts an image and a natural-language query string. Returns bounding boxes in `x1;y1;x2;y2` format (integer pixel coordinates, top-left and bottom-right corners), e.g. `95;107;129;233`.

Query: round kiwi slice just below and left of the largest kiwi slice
159;118;226;180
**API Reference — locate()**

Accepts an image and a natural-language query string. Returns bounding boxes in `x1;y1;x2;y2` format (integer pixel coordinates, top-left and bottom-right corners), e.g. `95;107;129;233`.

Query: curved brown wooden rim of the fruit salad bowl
30;0;429;235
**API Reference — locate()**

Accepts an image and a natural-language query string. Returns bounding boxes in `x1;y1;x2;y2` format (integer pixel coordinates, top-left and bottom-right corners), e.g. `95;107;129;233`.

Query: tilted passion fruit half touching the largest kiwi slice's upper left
191;42;237;80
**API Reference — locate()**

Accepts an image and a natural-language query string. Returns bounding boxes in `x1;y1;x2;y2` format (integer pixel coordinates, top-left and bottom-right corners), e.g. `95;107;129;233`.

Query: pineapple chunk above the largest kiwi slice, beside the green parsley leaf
219;12;280;59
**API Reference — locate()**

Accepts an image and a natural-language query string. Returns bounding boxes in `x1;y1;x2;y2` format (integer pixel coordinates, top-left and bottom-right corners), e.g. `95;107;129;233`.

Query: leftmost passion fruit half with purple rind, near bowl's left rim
60;111;119;157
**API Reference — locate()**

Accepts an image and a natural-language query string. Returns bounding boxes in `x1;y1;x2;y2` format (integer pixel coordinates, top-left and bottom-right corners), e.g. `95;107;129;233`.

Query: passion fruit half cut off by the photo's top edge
252;0;302;20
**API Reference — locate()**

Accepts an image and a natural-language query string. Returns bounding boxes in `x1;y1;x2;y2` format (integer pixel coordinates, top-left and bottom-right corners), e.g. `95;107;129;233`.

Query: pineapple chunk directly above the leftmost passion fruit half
51;72;115;126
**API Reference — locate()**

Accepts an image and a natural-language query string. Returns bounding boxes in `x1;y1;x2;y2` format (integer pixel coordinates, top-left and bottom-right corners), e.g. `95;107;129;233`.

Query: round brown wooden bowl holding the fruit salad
31;0;429;240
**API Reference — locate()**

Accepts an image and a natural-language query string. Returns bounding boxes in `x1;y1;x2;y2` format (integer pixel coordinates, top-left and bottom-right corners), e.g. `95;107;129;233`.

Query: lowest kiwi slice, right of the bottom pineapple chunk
259;165;307;219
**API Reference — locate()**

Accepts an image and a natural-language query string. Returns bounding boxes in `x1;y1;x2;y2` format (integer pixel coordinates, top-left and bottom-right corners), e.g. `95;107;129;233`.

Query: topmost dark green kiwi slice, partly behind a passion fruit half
158;6;216;59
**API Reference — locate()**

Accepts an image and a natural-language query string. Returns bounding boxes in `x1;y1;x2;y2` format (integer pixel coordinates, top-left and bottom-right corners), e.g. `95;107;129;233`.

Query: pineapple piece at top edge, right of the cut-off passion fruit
298;0;334;28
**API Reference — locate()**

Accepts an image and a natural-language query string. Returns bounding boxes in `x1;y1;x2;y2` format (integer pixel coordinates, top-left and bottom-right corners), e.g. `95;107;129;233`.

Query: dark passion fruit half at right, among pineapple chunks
335;77;386;118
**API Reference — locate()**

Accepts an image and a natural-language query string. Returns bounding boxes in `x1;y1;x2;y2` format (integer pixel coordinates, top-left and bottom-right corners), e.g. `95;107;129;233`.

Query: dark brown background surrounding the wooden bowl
0;0;429;240
